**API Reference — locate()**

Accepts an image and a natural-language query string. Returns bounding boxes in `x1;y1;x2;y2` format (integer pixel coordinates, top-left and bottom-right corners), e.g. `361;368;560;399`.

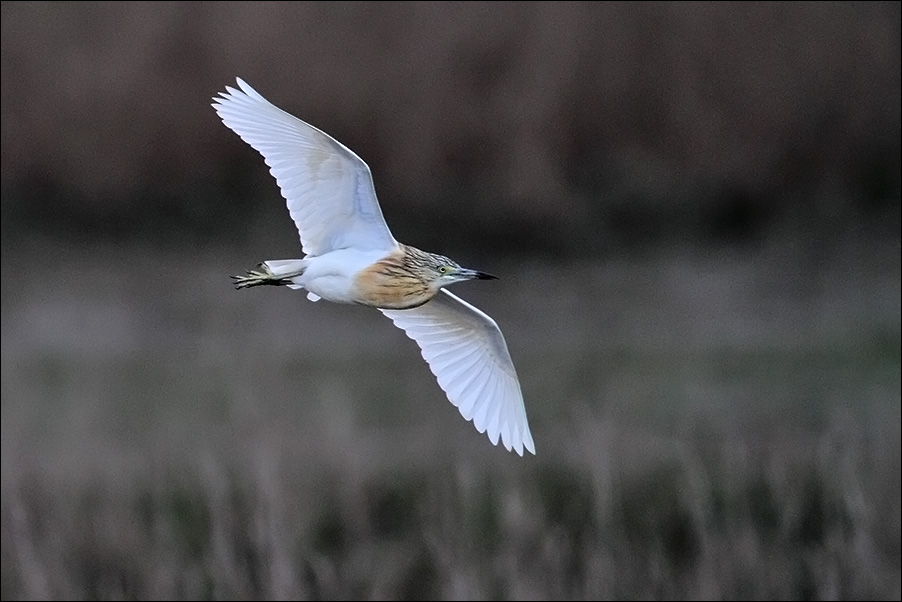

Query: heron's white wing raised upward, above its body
213;78;397;255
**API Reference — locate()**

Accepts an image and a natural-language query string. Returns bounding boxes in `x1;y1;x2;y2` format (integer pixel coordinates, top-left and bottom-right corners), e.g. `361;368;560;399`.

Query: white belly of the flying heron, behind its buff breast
292;249;388;303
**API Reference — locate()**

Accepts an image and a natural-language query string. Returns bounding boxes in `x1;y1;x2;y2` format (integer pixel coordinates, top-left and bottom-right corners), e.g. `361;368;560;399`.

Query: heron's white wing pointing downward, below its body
380;289;536;456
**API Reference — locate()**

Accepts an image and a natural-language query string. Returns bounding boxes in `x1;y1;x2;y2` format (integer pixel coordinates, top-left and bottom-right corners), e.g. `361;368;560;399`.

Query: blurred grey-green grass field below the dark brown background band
0;240;902;599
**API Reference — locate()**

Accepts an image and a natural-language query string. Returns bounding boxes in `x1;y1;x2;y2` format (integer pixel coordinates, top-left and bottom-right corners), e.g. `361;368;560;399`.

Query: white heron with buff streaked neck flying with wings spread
212;78;536;456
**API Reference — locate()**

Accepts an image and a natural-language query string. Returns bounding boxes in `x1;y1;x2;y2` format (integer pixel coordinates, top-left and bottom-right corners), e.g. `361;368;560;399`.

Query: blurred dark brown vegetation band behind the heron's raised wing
0;2;902;255
